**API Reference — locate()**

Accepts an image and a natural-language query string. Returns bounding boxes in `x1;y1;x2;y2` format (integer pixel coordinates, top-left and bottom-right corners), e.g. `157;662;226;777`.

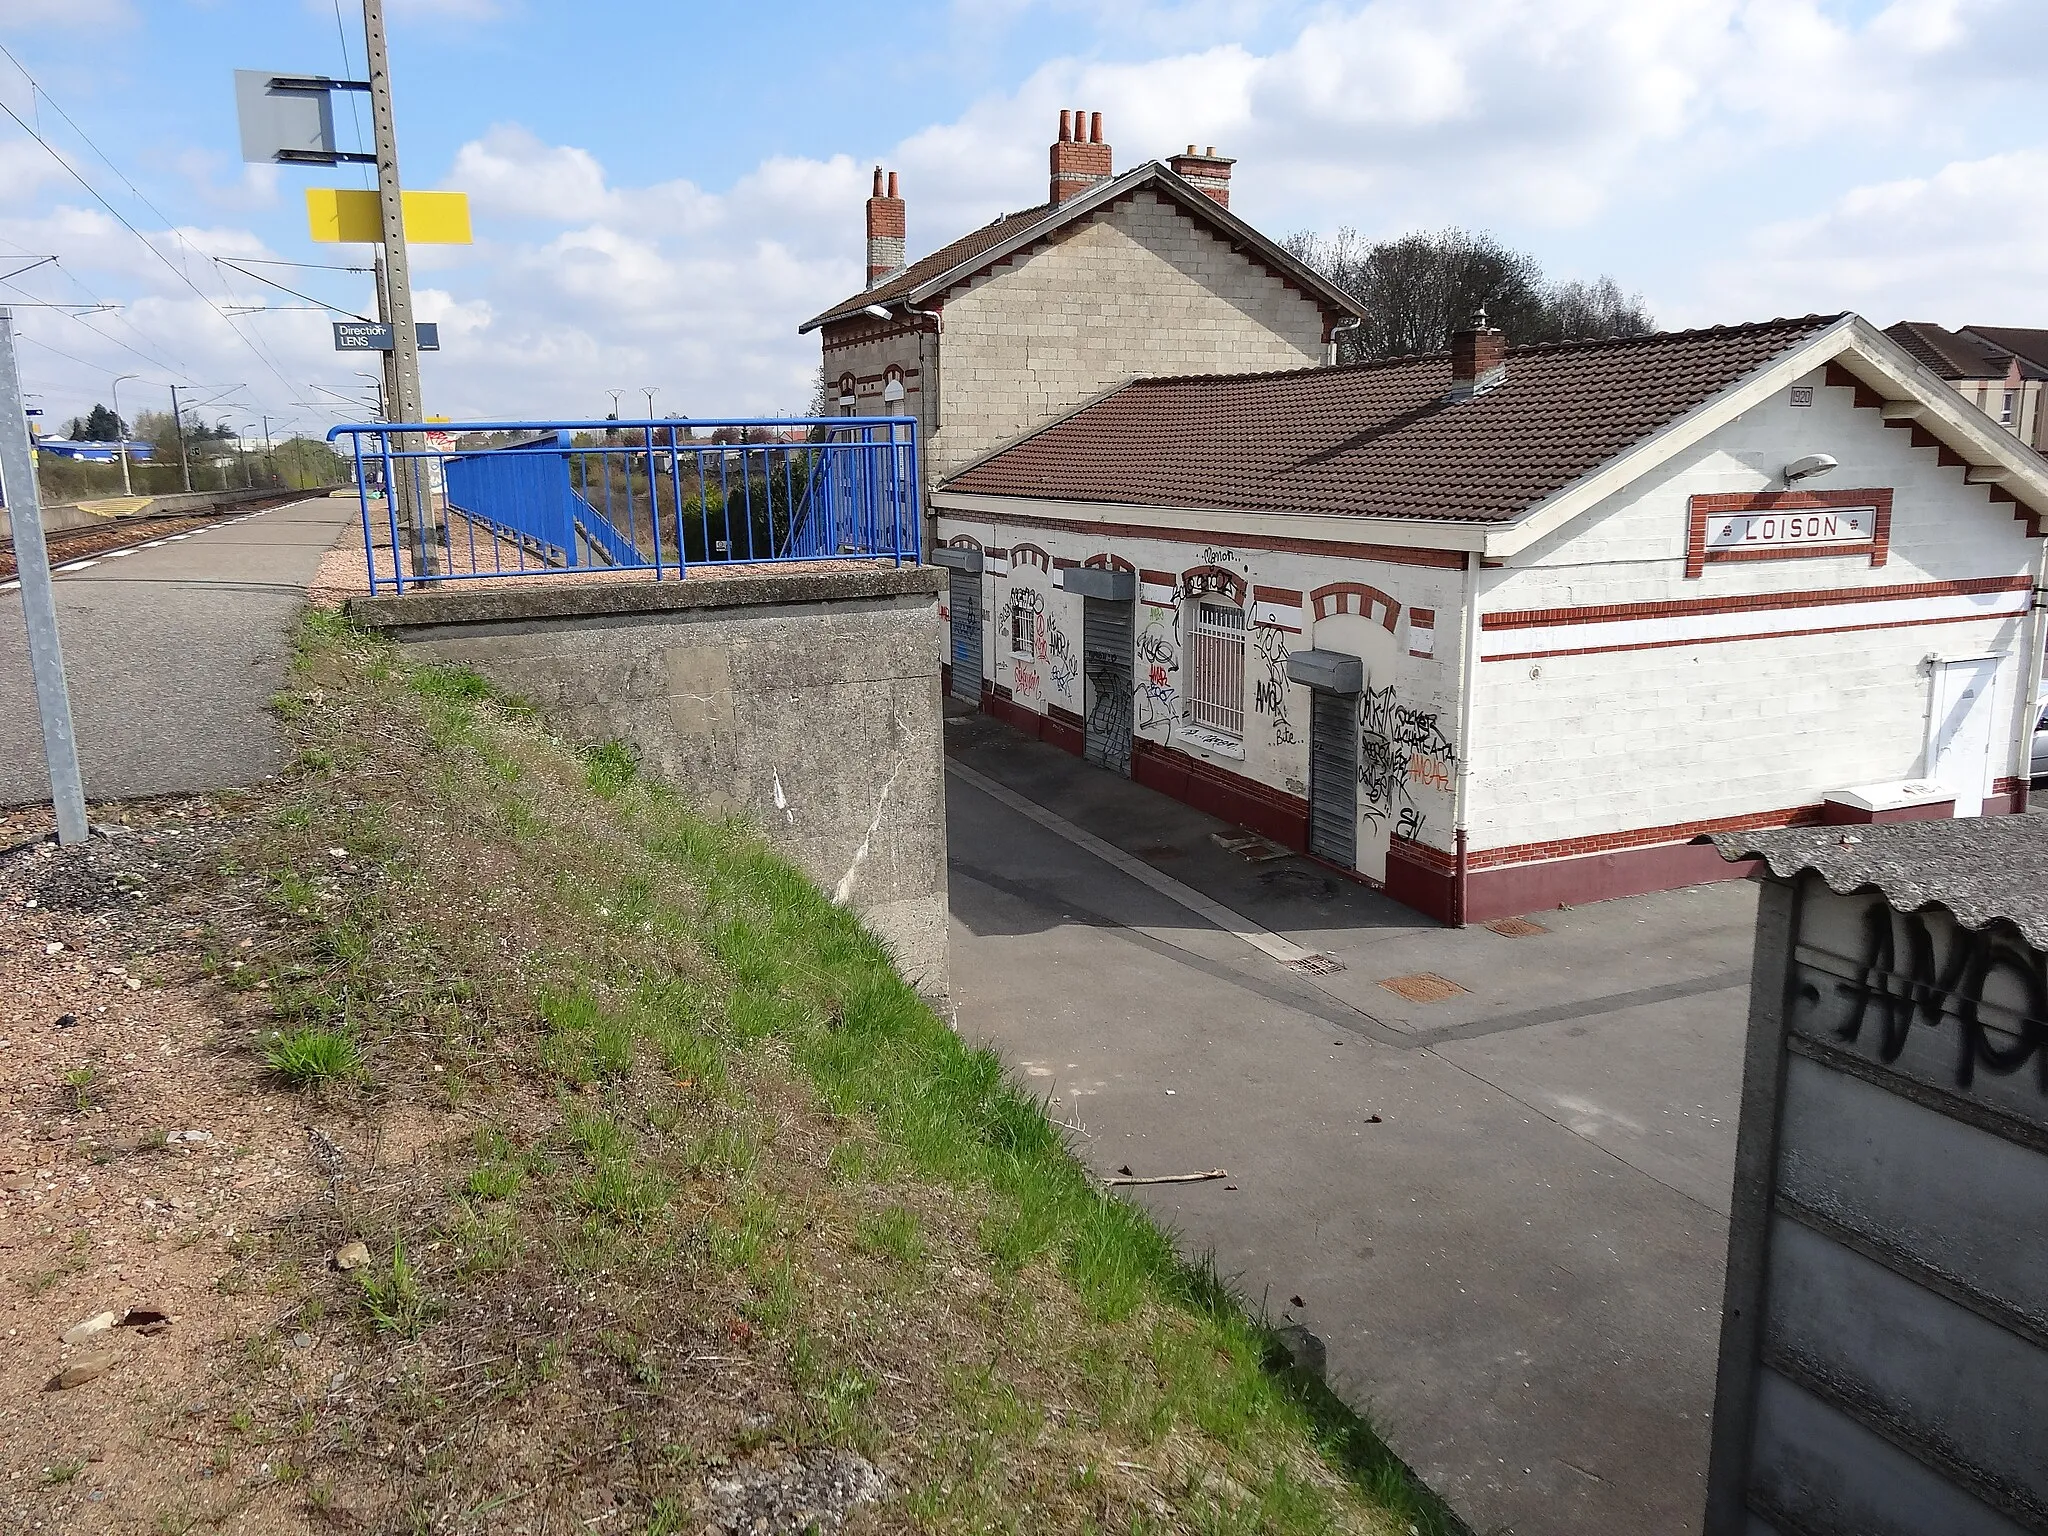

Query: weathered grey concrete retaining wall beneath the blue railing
350;567;946;995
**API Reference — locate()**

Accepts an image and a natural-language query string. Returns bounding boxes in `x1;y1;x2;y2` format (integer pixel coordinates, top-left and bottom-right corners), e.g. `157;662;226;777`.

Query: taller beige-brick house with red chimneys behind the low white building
801;111;1354;495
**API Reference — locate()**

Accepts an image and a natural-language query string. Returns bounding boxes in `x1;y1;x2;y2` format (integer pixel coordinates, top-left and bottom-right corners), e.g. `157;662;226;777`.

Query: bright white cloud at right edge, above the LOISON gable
1704;150;2048;326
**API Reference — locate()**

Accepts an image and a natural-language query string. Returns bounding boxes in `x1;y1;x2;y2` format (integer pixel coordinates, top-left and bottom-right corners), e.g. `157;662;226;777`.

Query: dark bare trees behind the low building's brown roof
1286;227;1653;362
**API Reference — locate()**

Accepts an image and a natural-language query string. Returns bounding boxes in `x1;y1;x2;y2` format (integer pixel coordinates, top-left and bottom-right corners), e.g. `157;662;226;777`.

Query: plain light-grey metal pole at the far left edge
0;309;86;844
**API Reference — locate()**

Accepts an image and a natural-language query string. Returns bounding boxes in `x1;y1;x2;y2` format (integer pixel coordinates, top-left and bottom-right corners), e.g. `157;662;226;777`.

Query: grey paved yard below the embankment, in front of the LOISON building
948;717;1755;1536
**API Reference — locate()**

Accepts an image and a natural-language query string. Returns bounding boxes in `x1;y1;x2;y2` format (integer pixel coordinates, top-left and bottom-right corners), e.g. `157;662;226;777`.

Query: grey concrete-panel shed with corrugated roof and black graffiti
1706;843;2048;1536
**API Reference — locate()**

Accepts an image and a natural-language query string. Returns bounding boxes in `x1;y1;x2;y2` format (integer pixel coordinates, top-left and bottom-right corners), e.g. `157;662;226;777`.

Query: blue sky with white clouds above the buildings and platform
0;0;2048;430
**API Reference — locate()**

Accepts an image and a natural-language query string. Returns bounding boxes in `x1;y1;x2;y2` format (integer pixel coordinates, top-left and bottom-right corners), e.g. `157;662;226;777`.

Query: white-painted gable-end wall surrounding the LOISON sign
1468;373;2034;850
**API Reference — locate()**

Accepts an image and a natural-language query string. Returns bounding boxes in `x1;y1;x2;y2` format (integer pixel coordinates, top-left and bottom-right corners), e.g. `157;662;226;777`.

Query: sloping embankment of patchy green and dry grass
232;614;1452;1536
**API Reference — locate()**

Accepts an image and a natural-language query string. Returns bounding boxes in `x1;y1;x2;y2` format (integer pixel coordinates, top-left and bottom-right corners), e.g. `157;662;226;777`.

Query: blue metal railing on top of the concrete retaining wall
328;416;922;592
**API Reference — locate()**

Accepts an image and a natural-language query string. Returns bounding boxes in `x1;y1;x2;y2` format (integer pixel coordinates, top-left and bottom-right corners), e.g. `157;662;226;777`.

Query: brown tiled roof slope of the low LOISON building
944;315;1841;522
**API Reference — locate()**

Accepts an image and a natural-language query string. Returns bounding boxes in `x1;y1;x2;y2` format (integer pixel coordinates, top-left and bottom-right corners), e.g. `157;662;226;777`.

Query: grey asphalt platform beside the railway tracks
0;498;356;805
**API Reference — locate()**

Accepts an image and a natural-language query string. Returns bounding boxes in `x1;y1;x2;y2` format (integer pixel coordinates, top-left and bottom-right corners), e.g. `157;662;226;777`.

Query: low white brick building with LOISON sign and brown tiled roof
934;315;2048;922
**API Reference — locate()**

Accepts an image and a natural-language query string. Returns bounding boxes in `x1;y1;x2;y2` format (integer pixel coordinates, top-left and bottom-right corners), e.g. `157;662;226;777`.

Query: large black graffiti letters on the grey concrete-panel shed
1800;899;2048;1094
